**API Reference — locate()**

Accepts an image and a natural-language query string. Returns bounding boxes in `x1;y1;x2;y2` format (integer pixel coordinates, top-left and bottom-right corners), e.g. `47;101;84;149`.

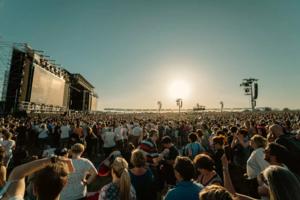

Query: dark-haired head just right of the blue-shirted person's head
193;154;215;174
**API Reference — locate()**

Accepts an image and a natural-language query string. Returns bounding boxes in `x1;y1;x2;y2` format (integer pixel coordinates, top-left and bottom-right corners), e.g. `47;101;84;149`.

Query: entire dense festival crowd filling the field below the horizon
0;112;300;200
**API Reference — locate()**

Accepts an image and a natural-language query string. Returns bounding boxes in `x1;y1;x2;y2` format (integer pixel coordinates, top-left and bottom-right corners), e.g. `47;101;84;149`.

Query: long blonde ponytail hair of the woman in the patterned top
111;157;131;200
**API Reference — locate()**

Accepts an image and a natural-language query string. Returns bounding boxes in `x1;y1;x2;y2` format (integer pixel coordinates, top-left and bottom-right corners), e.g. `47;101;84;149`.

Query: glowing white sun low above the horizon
169;80;190;99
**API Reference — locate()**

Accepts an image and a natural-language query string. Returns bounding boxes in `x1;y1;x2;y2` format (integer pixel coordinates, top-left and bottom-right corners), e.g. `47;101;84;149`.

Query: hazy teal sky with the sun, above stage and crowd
0;0;300;109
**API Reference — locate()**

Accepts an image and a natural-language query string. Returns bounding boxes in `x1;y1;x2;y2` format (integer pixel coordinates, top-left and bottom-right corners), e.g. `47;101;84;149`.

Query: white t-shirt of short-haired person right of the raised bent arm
60;158;97;200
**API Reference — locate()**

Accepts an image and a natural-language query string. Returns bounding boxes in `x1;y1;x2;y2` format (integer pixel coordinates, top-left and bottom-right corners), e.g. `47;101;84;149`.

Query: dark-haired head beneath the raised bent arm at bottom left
33;163;68;200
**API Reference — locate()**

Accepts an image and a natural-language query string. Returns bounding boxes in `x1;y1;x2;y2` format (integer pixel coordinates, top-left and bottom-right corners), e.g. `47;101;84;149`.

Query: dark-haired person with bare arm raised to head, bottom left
0;156;73;200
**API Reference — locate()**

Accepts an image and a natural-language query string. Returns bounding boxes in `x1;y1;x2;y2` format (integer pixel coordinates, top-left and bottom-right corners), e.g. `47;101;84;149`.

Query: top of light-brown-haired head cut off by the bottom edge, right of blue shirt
199;185;234;200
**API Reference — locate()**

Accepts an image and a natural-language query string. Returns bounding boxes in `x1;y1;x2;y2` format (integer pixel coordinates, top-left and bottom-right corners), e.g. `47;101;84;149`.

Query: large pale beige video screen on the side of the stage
30;64;65;106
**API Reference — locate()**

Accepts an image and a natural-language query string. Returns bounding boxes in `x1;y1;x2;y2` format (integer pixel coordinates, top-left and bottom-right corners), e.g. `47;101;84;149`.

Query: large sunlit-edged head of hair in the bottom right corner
262;165;300;200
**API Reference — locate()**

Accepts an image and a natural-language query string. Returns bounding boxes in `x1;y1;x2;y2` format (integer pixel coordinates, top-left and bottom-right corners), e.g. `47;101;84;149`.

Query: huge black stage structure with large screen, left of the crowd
5;45;98;113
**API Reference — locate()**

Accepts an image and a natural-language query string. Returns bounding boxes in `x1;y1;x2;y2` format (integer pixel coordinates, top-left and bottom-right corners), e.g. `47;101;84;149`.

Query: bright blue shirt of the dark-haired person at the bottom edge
165;181;203;200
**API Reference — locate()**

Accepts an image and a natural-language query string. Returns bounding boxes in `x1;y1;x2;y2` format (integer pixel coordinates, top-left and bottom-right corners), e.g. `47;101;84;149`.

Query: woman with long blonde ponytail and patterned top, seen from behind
99;157;136;200
